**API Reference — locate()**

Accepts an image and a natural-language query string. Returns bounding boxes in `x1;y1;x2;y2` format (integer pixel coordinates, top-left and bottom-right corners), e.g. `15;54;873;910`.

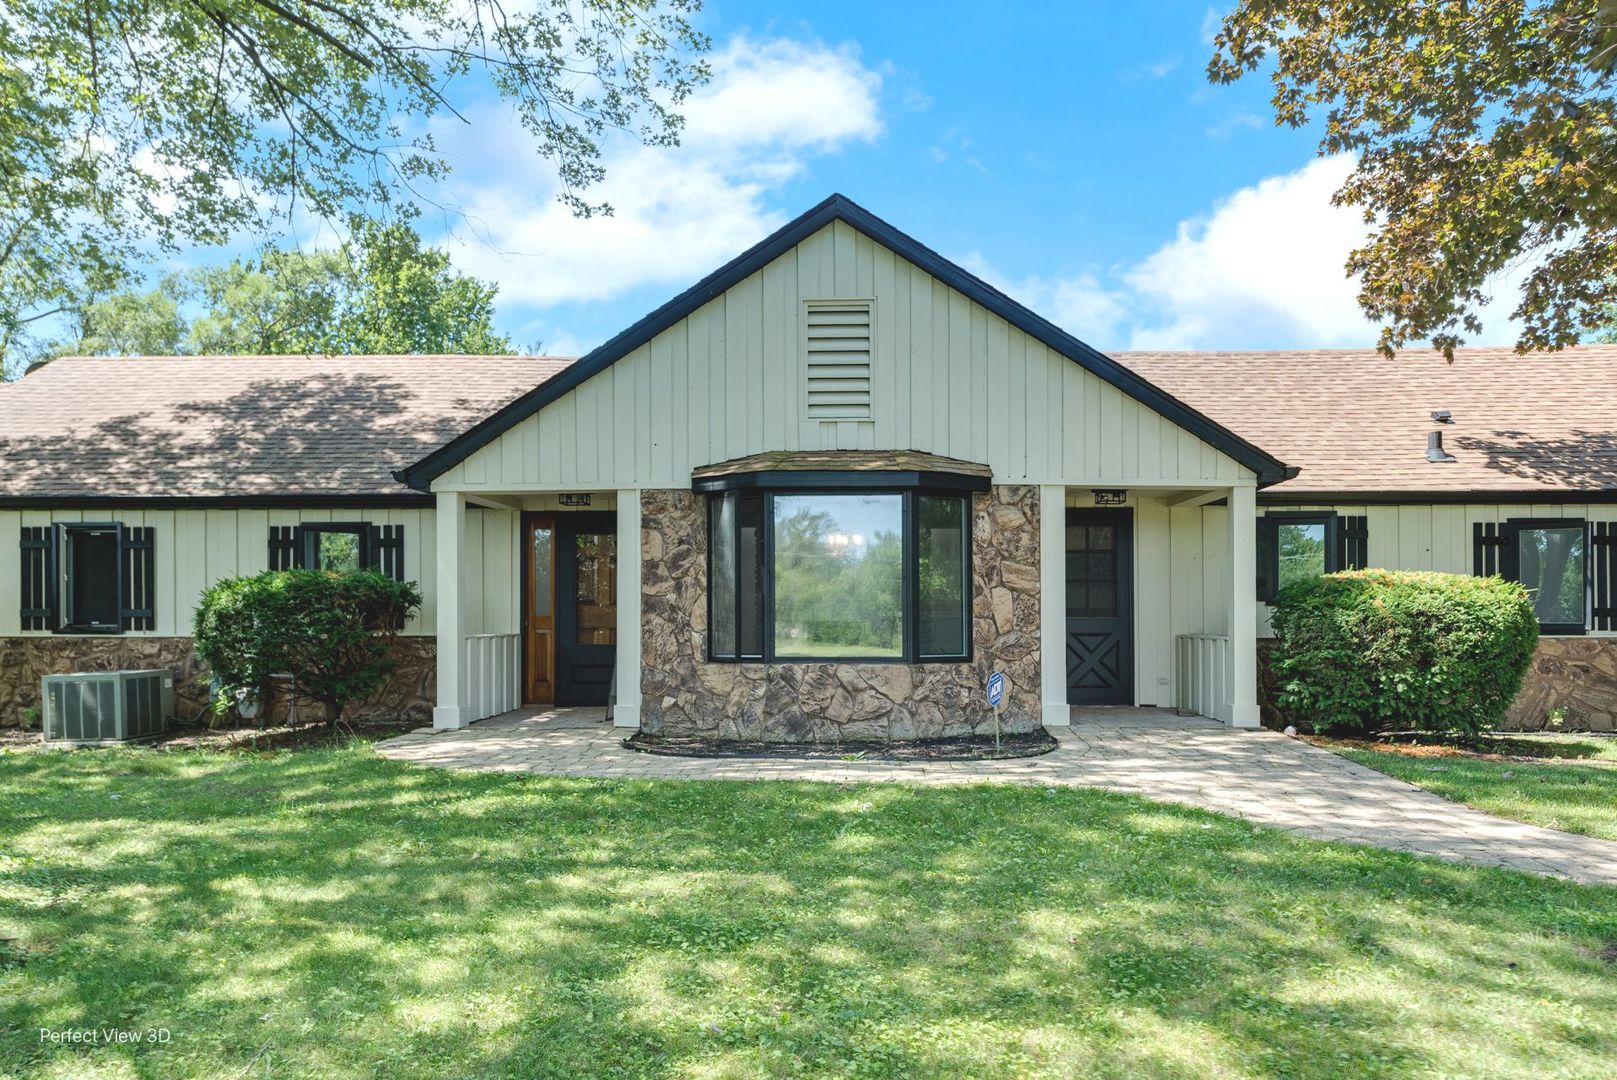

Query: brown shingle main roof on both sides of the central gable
0;344;1617;498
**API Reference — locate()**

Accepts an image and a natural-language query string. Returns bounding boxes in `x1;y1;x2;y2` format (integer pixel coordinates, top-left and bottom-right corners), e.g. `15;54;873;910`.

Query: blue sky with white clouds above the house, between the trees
291;0;1509;354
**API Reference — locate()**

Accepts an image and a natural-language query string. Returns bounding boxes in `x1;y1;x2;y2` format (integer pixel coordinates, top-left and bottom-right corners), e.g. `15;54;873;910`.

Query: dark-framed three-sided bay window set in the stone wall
708;487;972;663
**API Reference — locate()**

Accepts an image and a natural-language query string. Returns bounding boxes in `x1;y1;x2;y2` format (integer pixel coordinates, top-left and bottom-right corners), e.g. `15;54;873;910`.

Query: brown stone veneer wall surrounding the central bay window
640;485;1041;742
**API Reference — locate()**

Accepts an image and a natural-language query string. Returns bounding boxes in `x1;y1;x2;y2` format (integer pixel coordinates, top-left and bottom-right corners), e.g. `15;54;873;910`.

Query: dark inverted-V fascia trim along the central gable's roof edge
393;194;1297;491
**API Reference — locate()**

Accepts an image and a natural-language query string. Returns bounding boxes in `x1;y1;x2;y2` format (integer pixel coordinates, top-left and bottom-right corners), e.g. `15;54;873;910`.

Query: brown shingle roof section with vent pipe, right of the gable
1111;344;1617;495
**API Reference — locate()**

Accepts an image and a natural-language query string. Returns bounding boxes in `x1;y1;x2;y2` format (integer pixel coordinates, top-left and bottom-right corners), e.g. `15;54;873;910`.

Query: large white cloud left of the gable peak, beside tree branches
438;37;883;306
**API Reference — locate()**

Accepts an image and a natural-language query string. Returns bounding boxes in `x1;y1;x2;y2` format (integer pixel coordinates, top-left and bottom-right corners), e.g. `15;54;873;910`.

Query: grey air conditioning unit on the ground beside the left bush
39;669;175;747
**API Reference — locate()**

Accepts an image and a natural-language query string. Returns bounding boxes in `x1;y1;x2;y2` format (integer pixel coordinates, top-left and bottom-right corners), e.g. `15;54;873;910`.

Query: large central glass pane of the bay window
775;495;904;658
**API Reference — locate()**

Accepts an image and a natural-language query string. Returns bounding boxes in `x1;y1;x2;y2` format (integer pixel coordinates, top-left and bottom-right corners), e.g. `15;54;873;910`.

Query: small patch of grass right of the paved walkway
1319;736;1617;841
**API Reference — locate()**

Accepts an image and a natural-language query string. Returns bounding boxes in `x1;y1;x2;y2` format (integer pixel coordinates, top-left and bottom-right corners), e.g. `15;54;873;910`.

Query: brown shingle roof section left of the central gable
0;356;571;498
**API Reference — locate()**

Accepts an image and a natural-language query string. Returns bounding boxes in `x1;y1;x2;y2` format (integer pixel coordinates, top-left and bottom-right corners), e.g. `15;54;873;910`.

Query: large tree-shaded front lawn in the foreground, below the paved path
0;747;1617;1080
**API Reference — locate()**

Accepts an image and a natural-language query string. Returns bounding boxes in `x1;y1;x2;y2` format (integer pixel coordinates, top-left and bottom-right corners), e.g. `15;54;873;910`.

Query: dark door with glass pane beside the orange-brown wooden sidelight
555;513;618;705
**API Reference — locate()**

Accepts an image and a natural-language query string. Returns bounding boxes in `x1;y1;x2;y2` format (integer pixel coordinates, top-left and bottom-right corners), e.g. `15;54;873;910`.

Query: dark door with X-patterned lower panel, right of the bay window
1067;509;1134;705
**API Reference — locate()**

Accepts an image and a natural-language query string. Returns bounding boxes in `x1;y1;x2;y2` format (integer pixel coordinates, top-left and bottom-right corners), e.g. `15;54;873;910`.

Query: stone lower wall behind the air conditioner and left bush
0;635;437;728
